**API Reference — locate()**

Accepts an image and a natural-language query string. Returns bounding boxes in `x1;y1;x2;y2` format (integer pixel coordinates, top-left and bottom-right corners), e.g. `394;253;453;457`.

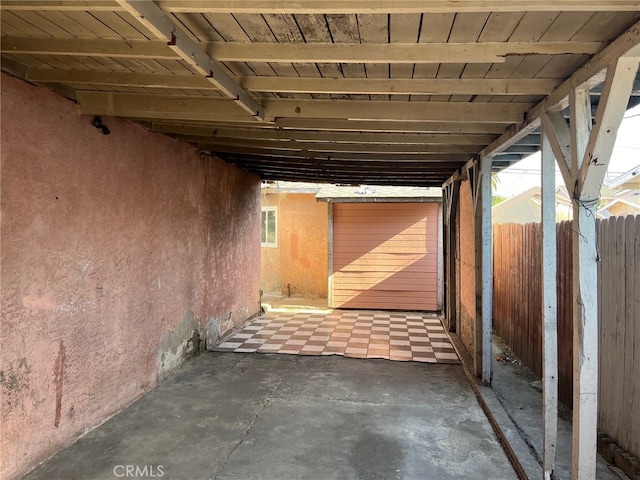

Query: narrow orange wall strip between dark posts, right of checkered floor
458;181;476;354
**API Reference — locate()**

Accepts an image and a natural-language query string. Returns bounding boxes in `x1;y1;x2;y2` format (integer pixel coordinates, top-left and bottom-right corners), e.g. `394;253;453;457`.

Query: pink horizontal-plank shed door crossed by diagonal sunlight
331;203;439;310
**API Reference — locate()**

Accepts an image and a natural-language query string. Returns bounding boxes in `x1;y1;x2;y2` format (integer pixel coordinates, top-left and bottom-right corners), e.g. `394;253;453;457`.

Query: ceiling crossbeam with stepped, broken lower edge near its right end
208;42;606;64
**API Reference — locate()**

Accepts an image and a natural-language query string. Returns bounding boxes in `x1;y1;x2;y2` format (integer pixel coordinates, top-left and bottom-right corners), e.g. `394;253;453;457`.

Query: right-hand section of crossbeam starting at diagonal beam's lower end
263;99;531;123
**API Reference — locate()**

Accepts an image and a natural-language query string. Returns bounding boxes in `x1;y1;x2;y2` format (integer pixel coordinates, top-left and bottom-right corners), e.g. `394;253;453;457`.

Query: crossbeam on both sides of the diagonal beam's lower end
77;91;529;123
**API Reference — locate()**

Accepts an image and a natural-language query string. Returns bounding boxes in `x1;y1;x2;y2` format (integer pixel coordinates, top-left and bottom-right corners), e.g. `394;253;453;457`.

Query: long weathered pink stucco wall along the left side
0;74;260;479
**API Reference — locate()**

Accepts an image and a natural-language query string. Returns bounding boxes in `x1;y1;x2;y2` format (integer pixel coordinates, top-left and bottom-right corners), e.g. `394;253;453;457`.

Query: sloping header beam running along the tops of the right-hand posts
481;18;640;156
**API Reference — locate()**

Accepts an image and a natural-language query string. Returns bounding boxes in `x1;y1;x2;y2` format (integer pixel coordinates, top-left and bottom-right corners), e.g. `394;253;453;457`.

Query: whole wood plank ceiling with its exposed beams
0;0;640;186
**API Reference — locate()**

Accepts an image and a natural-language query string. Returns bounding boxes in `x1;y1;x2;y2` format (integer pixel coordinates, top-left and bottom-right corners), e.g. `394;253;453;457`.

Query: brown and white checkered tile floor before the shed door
215;310;458;363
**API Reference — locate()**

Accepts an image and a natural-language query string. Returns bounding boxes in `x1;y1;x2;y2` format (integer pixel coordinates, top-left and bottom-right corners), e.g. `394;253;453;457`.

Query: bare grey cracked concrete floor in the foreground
25;352;516;480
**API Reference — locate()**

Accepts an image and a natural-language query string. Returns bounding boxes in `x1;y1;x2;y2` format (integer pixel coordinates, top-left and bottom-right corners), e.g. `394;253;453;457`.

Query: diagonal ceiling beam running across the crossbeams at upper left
117;0;264;120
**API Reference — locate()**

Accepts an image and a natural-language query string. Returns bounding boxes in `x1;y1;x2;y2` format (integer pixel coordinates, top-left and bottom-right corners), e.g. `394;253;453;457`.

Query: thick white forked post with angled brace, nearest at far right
569;57;638;480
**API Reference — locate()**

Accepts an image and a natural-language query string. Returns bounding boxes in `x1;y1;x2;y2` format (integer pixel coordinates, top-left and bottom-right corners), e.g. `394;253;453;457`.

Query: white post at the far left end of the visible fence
477;157;493;385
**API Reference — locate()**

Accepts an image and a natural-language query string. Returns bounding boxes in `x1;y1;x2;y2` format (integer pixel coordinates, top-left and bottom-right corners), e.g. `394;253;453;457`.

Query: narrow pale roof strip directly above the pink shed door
316;185;442;203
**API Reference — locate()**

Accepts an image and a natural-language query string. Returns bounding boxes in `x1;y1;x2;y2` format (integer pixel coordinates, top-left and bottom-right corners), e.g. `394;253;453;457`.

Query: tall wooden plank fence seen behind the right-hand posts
493;216;640;457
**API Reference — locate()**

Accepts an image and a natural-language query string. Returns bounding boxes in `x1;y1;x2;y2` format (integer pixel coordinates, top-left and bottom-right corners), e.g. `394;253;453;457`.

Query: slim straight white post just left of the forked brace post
542;129;558;480
